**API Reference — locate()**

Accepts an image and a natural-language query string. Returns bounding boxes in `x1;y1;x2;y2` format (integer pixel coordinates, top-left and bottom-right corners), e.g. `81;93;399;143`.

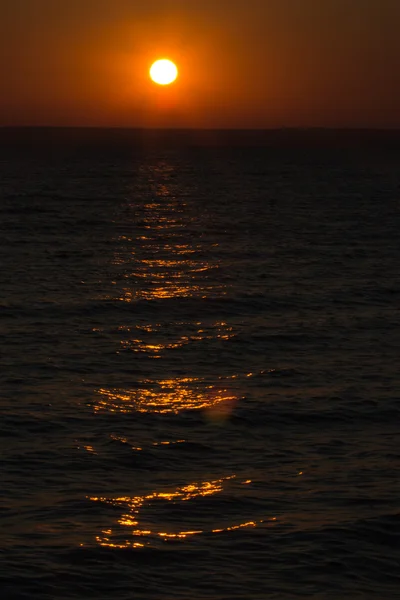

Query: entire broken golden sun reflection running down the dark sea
84;163;276;549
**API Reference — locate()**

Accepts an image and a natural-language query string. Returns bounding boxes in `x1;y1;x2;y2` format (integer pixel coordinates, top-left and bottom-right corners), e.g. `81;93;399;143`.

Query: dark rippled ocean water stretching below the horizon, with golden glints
0;130;400;600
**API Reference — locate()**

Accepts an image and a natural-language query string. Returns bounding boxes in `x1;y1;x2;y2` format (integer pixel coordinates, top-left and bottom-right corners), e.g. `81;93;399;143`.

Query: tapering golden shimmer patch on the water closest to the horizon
107;162;227;303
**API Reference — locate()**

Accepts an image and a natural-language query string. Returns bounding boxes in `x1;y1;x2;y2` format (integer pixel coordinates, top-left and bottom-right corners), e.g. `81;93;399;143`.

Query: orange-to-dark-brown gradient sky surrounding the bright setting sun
0;0;400;128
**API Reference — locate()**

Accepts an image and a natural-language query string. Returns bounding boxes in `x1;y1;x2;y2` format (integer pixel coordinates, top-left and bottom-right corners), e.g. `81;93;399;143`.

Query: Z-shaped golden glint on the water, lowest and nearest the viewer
89;475;276;549
